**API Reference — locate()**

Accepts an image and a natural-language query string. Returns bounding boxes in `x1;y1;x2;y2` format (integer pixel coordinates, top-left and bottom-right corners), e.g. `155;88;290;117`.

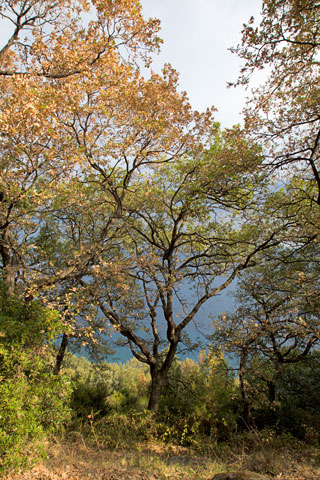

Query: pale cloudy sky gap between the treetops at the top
141;0;262;127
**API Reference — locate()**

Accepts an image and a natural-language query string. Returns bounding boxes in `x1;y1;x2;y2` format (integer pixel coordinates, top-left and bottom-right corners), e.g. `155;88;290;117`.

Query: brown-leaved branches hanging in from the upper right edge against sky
232;0;320;237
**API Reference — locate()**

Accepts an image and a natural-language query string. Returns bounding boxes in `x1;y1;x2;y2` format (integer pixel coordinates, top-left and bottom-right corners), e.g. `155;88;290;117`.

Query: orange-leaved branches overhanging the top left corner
0;0;161;80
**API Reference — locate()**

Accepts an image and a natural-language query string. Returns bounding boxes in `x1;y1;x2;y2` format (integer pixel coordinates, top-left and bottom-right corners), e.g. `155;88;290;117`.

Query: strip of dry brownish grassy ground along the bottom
6;435;320;480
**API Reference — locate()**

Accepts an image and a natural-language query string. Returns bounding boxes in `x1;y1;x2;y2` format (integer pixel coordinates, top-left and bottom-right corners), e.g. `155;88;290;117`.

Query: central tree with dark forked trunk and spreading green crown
74;128;279;412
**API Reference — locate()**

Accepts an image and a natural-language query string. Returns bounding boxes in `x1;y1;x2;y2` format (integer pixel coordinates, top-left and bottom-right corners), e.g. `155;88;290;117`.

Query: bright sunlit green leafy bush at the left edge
0;291;70;472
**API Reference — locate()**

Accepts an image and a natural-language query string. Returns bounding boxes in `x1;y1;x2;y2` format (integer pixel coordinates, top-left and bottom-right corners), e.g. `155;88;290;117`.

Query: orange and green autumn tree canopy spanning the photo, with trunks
0;0;320;426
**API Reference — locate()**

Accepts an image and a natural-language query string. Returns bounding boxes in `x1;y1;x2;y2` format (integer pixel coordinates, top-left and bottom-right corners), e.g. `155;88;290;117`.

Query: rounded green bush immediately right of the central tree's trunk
159;353;236;446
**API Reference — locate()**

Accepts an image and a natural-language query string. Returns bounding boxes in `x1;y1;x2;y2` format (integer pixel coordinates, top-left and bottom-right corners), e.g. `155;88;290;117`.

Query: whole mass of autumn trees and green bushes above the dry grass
0;0;320;480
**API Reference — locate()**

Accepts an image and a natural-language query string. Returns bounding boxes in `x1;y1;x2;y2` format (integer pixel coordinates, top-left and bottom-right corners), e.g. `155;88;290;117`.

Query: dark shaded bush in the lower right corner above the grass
239;351;320;442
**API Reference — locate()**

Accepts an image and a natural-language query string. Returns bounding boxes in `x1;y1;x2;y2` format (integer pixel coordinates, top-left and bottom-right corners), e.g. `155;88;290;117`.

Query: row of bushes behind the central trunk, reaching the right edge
65;351;320;449
